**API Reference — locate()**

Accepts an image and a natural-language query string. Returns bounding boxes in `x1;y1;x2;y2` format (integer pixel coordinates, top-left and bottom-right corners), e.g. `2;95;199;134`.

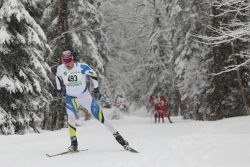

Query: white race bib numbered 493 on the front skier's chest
62;70;83;87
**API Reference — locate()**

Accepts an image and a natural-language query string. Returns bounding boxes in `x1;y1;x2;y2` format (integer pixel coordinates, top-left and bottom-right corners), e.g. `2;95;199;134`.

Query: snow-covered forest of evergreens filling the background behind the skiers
0;0;250;135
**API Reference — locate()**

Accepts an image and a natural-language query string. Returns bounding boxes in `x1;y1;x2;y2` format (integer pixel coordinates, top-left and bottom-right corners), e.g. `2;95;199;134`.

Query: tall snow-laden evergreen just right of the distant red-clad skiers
167;0;210;119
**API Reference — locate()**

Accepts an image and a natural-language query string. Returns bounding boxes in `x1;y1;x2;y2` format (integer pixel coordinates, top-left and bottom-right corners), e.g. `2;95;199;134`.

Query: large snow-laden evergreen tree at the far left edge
0;0;51;134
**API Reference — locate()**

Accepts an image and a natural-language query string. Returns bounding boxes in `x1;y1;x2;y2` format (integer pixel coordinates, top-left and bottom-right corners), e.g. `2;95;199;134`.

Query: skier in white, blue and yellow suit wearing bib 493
56;51;129;151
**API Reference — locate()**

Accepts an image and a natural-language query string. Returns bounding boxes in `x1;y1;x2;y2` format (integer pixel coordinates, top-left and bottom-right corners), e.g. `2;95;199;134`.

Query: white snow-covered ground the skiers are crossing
0;109;250;167
